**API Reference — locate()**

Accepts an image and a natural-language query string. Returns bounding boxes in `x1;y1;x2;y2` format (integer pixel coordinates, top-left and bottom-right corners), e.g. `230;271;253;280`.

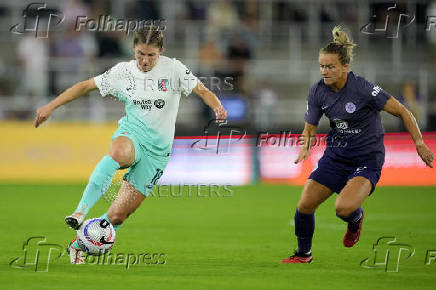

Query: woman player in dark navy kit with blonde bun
281;26;433;263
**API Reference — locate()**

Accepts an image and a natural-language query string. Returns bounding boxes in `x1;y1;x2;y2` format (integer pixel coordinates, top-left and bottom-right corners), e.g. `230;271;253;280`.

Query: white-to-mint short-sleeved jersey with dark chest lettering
94;55;199;156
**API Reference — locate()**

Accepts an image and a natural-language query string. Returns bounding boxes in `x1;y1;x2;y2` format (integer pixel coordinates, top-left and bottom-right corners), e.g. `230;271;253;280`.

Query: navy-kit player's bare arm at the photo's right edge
383;96;434;168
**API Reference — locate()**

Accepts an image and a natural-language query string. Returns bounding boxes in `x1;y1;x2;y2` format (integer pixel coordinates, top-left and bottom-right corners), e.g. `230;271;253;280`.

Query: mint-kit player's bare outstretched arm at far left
35;78;97;128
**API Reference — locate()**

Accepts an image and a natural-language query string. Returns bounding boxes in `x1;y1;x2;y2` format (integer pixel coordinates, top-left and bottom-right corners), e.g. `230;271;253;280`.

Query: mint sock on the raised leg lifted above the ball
76;155;120;216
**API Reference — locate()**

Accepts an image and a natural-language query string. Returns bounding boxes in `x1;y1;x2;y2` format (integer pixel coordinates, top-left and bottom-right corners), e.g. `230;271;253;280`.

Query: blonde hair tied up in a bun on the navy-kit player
320;25;356;65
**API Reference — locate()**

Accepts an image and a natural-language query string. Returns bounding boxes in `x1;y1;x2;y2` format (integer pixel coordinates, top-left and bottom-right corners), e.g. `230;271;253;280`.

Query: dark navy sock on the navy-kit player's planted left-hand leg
294;209;315;254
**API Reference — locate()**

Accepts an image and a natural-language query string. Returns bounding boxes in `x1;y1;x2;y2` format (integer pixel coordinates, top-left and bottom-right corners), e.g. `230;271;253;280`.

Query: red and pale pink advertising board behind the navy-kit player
258;133;436;185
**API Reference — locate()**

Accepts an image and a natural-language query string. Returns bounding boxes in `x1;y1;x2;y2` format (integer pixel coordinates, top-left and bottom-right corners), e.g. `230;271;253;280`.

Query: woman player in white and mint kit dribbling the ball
35;27;227;264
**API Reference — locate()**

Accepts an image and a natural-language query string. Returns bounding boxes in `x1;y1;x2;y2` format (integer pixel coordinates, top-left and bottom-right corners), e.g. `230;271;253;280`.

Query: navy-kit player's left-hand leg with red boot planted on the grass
282;179;333;263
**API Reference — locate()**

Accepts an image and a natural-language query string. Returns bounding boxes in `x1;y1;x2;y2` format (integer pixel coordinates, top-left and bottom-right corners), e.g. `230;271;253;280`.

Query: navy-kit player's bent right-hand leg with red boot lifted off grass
335;176;373;247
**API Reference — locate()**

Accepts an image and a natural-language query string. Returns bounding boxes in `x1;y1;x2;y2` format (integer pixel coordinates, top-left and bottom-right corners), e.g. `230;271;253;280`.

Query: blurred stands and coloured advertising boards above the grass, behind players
0;0;436;185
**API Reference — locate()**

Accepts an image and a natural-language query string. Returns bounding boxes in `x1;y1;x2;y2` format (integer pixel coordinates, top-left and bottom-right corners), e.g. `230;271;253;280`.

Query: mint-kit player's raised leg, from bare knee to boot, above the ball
65;136;135;229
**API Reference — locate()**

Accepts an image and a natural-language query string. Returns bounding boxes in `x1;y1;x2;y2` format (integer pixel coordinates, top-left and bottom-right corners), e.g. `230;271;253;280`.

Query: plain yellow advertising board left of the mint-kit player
0;122;116;182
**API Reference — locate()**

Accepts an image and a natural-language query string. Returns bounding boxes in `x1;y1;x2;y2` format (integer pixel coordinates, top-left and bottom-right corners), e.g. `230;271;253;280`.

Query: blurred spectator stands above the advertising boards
0;0;436;134
